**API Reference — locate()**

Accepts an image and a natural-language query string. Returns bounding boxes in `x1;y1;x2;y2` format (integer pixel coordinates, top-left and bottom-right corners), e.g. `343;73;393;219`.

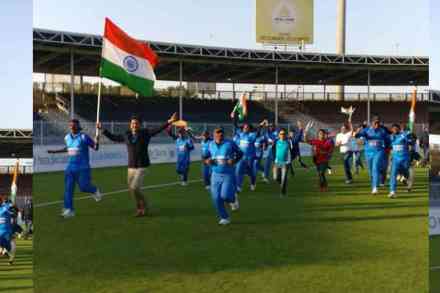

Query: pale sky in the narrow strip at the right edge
429;0;440;90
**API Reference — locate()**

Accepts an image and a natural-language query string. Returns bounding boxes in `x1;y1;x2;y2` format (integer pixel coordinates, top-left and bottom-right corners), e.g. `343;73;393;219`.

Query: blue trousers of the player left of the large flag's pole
64;169;97;210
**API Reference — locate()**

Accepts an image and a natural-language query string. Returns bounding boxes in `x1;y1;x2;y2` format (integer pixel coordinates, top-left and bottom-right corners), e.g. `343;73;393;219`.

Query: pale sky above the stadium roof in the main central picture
34;0;429;55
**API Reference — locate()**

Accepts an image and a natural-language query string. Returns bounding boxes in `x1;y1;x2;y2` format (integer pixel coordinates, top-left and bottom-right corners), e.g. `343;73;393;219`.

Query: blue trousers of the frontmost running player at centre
211;173;236;219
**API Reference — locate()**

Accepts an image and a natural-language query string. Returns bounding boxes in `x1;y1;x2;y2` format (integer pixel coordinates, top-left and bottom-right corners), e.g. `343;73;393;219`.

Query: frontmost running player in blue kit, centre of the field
204;128;243;225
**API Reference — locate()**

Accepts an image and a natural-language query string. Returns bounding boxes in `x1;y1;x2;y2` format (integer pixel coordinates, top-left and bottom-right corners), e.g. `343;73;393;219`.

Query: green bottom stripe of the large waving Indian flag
101;58;154;97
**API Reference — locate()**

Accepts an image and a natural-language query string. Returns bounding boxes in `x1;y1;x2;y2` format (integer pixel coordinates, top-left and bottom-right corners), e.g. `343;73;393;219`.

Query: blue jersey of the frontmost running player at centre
205;139;243;175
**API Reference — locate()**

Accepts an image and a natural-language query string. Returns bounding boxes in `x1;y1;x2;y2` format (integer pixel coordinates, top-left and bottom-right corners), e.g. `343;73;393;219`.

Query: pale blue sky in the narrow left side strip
0;0;32;129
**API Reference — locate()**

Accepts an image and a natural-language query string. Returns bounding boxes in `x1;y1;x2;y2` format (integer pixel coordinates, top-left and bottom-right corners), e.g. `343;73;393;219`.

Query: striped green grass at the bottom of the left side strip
0;239;34;293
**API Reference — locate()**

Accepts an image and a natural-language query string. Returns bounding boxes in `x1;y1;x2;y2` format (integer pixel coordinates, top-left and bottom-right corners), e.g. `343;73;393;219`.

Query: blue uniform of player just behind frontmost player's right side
234;128;258;192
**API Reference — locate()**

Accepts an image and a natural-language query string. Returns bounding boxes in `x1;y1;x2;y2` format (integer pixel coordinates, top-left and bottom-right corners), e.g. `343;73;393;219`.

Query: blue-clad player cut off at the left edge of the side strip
0;194;18;265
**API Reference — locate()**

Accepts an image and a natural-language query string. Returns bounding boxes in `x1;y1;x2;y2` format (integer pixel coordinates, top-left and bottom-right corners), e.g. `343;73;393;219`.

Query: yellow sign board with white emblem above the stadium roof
256;0;313;44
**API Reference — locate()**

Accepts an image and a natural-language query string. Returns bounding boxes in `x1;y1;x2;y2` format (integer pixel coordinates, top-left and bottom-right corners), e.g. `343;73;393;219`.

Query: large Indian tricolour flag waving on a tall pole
100;18;158;96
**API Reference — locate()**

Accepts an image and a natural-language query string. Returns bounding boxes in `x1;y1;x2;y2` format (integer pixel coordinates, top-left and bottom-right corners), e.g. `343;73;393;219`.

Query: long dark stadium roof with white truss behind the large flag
33;29;429;86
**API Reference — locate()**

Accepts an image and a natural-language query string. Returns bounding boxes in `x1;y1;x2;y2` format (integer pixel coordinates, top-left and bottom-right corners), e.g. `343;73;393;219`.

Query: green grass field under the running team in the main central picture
34;163;429;293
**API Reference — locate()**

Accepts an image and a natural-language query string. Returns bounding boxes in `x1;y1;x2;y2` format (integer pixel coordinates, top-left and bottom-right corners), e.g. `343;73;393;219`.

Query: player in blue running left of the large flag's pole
47;119;102;218
